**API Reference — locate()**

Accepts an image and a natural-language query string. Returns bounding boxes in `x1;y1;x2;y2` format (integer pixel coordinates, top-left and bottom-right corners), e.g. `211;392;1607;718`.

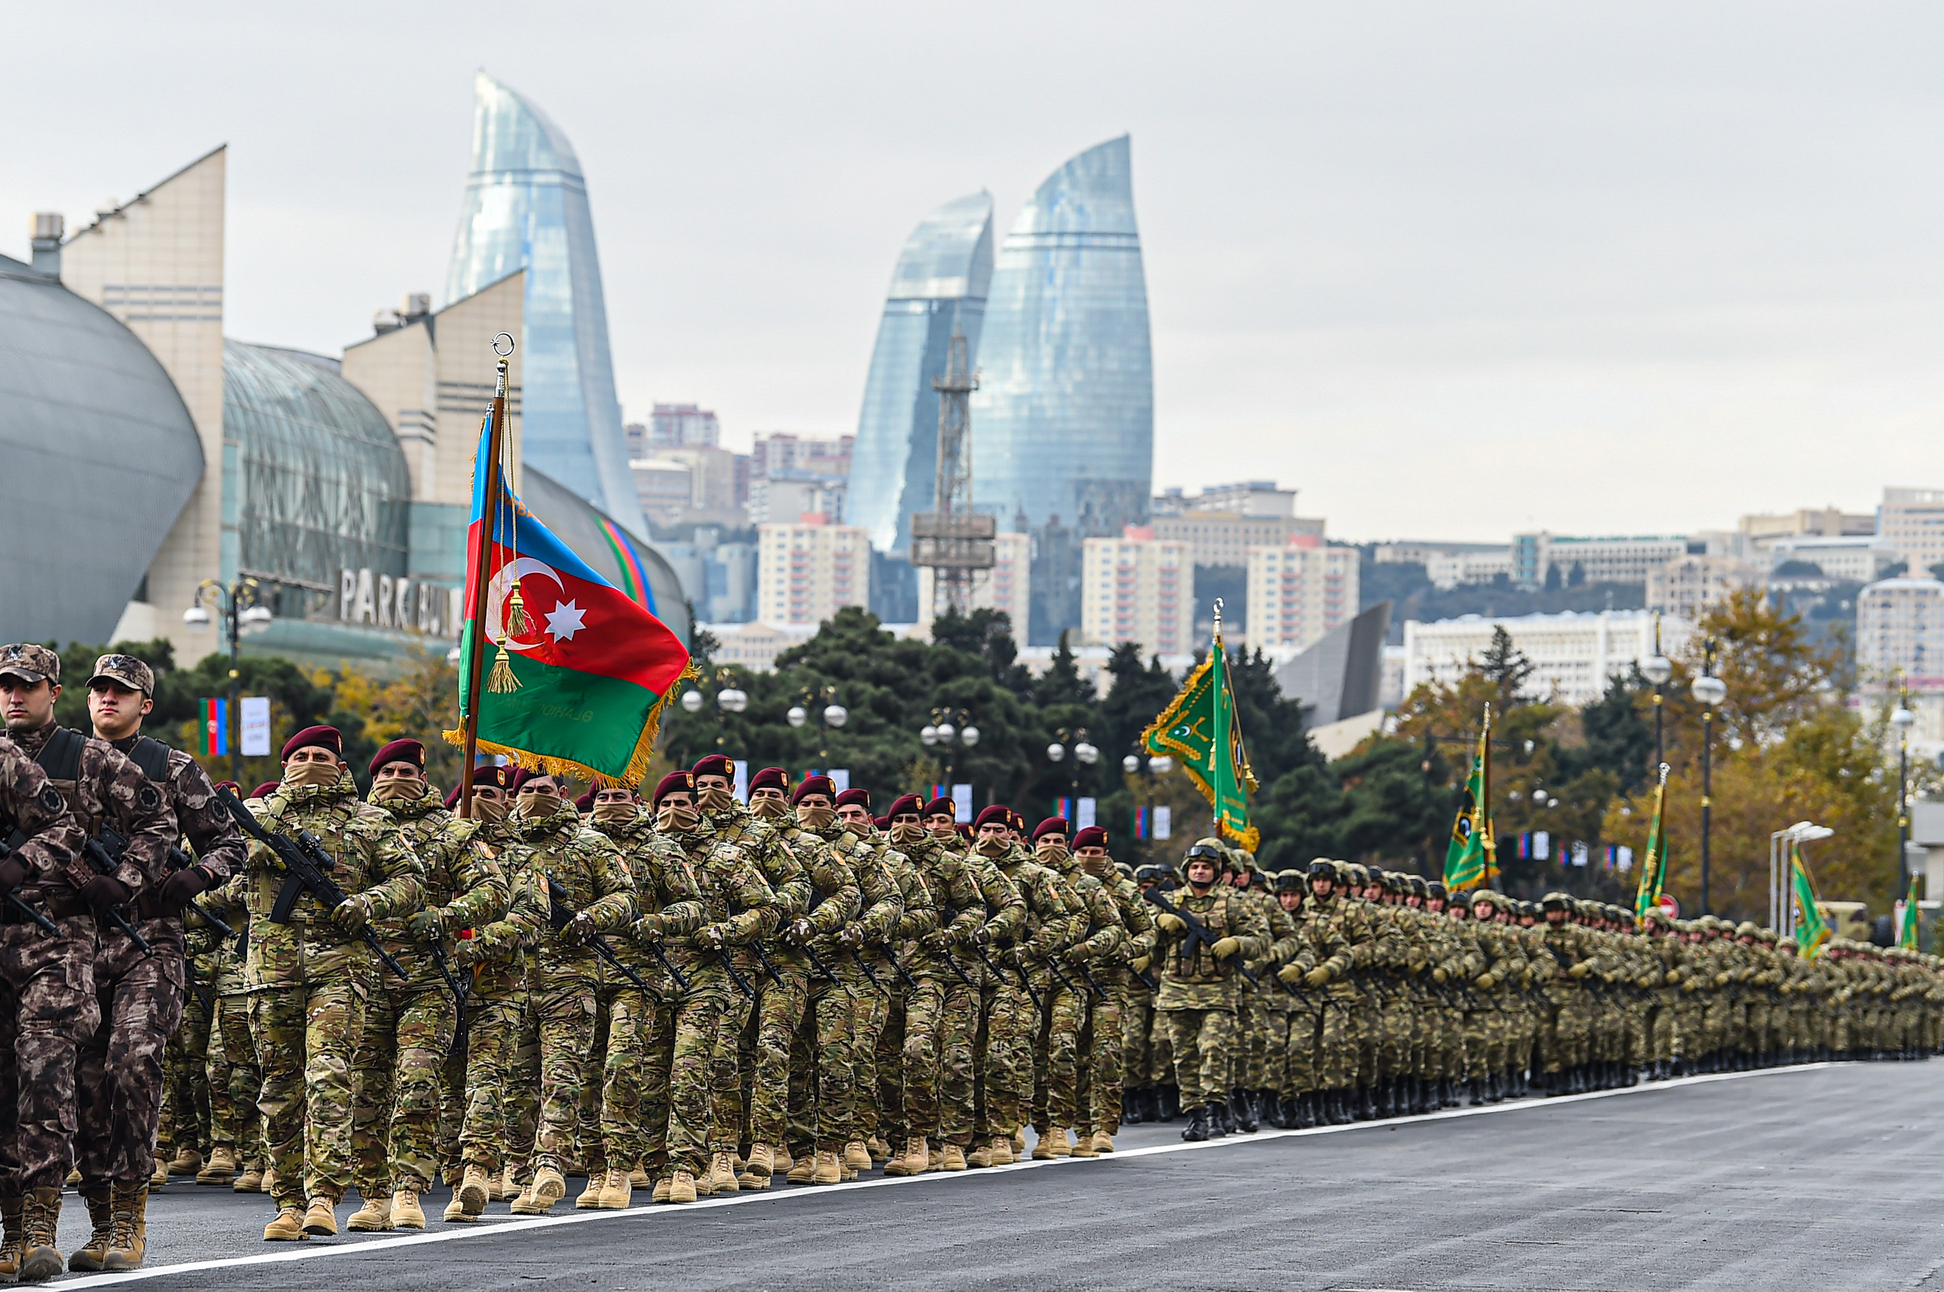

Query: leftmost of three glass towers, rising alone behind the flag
445;72;647;536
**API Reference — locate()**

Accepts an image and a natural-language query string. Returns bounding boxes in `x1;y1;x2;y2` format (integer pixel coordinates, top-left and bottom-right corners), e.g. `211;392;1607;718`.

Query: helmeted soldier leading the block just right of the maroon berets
1155;839;1269;1140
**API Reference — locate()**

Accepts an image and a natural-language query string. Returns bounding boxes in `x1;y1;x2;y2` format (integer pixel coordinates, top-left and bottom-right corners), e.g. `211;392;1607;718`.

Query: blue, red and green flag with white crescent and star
445;416;690;785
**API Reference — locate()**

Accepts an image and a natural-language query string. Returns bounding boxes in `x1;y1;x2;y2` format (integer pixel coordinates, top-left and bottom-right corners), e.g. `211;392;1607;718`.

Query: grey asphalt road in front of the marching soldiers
49;1061;1944;1292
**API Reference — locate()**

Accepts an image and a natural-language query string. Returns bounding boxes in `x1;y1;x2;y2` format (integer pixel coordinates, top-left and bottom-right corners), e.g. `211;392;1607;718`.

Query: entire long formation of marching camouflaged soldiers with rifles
0;645;1940;1280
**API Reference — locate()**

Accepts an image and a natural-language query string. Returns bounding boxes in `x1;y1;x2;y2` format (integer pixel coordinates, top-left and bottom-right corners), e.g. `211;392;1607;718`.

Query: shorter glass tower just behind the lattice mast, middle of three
844;192;991;556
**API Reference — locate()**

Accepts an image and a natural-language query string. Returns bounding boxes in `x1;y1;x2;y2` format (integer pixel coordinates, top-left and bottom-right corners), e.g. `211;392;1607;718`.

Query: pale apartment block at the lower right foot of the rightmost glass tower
1081;525;1196;655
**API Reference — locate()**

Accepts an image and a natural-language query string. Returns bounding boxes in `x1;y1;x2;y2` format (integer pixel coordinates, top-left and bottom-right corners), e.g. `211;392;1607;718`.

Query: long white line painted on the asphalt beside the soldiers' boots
60;1063;1833;1288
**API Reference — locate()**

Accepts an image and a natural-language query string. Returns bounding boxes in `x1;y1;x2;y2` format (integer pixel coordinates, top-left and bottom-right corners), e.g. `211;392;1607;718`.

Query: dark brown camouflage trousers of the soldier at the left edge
0;915;101;1199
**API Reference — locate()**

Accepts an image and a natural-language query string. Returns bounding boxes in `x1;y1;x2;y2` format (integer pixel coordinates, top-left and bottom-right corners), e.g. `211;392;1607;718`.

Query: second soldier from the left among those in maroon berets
346;738;507;1230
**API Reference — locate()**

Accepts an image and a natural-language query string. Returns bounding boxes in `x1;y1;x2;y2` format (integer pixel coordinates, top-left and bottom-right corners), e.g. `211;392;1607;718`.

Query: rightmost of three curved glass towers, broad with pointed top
972;136;1155;641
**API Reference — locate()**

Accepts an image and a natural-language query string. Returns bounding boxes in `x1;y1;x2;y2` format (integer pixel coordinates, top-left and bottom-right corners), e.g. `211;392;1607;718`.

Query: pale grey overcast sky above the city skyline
0;0;1944;540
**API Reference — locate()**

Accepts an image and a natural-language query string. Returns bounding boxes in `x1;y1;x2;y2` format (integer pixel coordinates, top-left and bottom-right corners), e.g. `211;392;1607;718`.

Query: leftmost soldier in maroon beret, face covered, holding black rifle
245;727;426;1241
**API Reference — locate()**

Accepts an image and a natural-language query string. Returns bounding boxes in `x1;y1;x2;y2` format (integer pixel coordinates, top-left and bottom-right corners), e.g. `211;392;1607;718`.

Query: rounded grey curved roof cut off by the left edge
0;256;202;641
